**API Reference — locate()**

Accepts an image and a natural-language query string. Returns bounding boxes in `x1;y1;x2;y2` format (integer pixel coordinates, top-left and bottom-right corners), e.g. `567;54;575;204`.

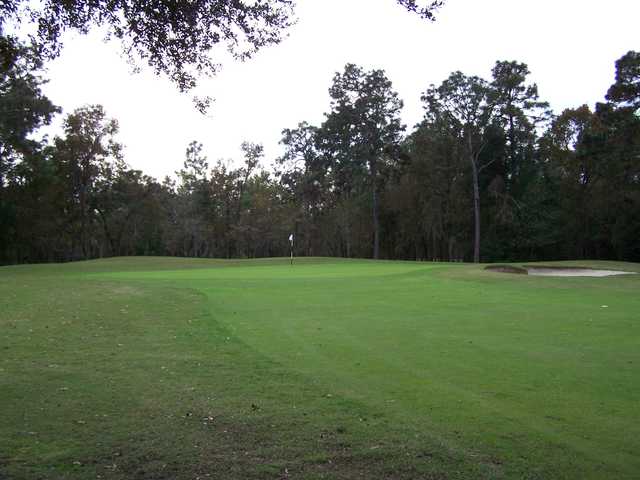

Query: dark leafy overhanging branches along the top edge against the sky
0;0;443;111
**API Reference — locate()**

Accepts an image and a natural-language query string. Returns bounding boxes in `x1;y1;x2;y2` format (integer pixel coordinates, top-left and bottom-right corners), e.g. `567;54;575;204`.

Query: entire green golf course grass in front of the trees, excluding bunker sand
0;258;640;480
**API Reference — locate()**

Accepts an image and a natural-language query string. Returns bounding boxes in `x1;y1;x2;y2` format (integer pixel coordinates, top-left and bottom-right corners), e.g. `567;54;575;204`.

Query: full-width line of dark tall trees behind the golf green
0;41;640;263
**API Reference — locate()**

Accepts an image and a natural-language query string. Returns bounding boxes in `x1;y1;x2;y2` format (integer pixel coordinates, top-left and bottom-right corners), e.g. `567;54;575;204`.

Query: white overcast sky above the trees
44;0;640;178
